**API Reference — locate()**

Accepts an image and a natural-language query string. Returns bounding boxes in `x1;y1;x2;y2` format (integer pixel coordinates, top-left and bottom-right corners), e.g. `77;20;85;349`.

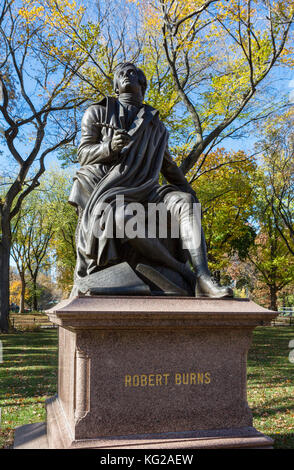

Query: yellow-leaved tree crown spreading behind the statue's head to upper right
28;0;294;174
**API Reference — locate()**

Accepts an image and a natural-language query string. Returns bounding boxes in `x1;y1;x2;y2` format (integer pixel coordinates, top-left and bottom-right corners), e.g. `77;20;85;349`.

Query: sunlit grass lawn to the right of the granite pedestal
247;326;294;449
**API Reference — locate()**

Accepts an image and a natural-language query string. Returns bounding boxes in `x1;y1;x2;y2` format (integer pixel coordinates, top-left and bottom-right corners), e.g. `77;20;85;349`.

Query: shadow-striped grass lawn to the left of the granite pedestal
0;328;57;448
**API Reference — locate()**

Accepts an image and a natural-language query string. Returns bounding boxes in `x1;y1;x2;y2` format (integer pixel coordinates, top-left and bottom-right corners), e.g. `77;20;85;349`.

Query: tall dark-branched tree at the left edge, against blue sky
0;0;85;331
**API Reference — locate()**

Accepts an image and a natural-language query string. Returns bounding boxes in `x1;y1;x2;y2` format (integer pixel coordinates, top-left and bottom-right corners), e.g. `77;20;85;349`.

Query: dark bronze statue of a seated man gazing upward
69;63;233;298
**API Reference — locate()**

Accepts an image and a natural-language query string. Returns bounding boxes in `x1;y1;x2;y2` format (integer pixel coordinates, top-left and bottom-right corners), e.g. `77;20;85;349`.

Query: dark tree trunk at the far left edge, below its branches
0;210;11;332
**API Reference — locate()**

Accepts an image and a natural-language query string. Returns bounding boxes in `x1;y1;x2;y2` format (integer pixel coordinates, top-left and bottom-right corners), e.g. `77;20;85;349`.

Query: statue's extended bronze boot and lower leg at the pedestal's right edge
189;229;234;298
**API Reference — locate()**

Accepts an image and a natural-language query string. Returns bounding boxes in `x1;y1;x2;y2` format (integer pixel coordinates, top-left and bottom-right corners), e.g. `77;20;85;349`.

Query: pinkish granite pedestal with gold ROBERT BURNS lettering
15;296;276;449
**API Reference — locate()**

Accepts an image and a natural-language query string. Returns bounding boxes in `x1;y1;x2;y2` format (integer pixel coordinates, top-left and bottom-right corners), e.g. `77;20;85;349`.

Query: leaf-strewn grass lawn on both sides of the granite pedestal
0;327;294;449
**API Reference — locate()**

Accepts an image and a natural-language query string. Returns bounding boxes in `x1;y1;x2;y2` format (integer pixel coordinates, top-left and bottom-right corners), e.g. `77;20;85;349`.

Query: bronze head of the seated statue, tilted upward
113;62;147;99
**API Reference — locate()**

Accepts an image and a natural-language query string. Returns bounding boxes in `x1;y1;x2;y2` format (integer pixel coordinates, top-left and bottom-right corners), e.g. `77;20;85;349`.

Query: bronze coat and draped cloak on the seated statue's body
69;97;193;276
